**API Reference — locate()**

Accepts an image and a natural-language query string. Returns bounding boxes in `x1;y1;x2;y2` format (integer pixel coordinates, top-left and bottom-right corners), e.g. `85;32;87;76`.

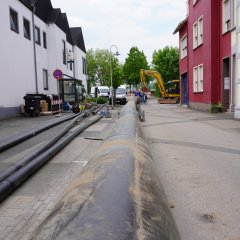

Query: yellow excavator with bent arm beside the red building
140;69;180;104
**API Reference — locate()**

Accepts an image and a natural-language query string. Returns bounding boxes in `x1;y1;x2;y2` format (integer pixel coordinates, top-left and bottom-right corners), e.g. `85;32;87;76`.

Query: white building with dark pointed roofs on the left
0;0;87;119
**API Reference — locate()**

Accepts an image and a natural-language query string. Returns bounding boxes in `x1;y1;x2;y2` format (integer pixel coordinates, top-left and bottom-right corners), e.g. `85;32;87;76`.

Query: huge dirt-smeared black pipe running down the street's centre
30;101;180;240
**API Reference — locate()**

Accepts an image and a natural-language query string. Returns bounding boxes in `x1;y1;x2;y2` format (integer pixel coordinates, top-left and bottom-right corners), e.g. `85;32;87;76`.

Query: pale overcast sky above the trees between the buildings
51;0;186;64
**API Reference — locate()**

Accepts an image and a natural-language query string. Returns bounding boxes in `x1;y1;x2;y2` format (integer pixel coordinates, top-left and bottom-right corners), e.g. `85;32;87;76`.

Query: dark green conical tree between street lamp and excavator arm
123;47;149;87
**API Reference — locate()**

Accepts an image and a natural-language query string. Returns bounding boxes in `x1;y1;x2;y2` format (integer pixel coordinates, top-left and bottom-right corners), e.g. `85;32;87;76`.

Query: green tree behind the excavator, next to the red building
152;47;179;82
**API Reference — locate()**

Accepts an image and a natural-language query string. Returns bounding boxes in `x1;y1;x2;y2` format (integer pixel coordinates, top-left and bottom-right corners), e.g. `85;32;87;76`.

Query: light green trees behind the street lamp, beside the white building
87;49;123;93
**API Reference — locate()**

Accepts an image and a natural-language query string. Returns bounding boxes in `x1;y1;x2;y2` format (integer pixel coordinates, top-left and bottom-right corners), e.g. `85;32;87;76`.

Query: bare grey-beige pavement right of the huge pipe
142;99;240;240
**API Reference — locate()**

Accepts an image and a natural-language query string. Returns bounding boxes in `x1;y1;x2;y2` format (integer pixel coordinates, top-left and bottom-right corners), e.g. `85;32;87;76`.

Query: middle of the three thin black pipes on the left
0;113;85;182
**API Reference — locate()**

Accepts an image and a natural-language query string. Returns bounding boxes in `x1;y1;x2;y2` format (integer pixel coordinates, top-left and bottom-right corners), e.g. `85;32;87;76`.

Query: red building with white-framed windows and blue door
174;0;234;111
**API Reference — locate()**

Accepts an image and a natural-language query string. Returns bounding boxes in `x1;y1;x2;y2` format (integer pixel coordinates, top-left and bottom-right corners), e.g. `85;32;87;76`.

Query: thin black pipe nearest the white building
0;114;80;153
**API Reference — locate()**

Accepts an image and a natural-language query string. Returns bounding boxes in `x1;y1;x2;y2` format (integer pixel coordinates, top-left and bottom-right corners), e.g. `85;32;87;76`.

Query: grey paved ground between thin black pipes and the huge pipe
0;107;119;240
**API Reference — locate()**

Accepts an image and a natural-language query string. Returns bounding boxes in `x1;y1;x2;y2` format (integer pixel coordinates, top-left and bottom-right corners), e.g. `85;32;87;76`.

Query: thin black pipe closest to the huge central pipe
0;115;102;202
